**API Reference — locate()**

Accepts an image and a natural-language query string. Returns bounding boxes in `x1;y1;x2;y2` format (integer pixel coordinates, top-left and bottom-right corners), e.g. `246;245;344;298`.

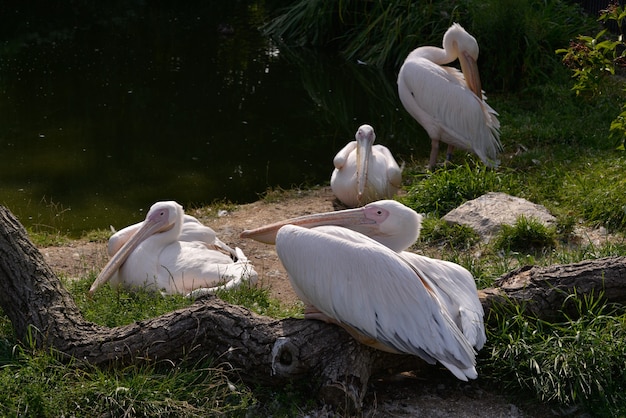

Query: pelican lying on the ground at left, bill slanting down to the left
89;201;258;296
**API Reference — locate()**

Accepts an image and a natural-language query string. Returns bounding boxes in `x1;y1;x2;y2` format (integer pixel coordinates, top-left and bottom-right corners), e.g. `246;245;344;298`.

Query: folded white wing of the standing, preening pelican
398;56;502;166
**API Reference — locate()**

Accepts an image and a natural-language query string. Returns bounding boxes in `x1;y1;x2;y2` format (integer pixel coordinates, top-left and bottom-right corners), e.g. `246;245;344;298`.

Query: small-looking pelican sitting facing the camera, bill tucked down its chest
330;125;402;208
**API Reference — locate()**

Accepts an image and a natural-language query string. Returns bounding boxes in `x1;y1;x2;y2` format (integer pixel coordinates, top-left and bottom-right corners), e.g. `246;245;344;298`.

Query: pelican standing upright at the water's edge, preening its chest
398;23;502;170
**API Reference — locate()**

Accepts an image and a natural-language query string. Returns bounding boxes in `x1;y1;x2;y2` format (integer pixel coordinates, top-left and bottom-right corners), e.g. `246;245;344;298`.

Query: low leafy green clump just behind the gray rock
401;163;519;216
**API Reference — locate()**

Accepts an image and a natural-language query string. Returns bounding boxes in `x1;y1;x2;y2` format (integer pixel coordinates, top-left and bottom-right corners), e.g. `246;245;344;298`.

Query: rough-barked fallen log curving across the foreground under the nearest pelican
0;206;626;407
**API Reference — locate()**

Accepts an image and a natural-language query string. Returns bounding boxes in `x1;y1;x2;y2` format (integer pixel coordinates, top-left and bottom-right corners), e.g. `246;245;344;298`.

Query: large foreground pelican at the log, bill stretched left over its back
241;200;486;380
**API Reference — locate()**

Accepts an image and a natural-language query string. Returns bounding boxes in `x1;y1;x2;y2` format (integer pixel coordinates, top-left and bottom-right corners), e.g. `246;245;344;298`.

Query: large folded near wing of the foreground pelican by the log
276;225;477;380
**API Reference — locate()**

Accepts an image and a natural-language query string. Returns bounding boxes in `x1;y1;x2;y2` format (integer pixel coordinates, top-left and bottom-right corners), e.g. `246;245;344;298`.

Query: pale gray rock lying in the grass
443;192;556;242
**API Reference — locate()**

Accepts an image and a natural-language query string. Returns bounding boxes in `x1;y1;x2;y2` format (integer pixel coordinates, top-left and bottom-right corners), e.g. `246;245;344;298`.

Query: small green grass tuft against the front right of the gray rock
493;215;556;253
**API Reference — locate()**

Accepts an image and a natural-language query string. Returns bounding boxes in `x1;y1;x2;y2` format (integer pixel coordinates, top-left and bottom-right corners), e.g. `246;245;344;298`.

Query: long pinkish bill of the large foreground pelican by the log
240;208;375;244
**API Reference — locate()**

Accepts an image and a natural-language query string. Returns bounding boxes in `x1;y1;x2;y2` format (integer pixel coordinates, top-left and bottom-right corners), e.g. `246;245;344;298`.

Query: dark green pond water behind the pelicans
0;1;429;236
